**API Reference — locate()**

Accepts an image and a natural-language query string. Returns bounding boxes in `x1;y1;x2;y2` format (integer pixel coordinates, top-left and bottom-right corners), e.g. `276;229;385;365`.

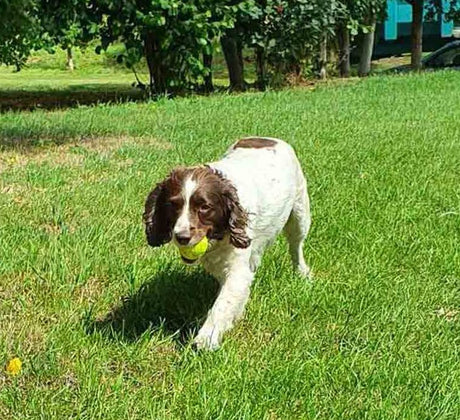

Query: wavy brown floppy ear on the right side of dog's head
226;186;251;248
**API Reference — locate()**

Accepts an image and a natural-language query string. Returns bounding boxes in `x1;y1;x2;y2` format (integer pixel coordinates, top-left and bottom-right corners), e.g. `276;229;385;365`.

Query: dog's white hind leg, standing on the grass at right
284;175;312;278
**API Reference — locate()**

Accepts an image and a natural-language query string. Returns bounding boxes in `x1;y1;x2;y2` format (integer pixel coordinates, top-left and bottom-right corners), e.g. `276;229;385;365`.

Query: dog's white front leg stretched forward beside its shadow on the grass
194;264;254;350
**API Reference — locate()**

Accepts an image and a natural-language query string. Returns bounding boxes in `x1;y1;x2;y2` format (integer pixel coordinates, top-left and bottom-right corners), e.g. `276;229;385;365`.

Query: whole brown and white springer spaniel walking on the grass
144;137;311;350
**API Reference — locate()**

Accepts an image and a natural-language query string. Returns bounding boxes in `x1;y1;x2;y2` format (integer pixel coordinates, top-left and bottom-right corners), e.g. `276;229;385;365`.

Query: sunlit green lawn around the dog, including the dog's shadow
0;72;460;420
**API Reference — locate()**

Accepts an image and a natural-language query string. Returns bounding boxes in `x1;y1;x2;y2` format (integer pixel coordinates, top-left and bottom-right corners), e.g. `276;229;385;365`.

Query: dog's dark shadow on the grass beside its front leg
88;270;219;344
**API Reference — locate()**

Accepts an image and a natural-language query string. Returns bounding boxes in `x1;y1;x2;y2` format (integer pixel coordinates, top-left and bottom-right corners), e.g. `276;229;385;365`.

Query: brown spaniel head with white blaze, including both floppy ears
144;167;250;258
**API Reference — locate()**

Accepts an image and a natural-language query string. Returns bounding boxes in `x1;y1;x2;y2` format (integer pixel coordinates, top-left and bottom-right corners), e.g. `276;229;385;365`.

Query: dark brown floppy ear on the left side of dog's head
143;179;173;247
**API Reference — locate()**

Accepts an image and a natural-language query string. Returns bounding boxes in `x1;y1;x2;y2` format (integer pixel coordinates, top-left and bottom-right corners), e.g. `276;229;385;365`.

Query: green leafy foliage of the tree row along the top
0;0;460;86
